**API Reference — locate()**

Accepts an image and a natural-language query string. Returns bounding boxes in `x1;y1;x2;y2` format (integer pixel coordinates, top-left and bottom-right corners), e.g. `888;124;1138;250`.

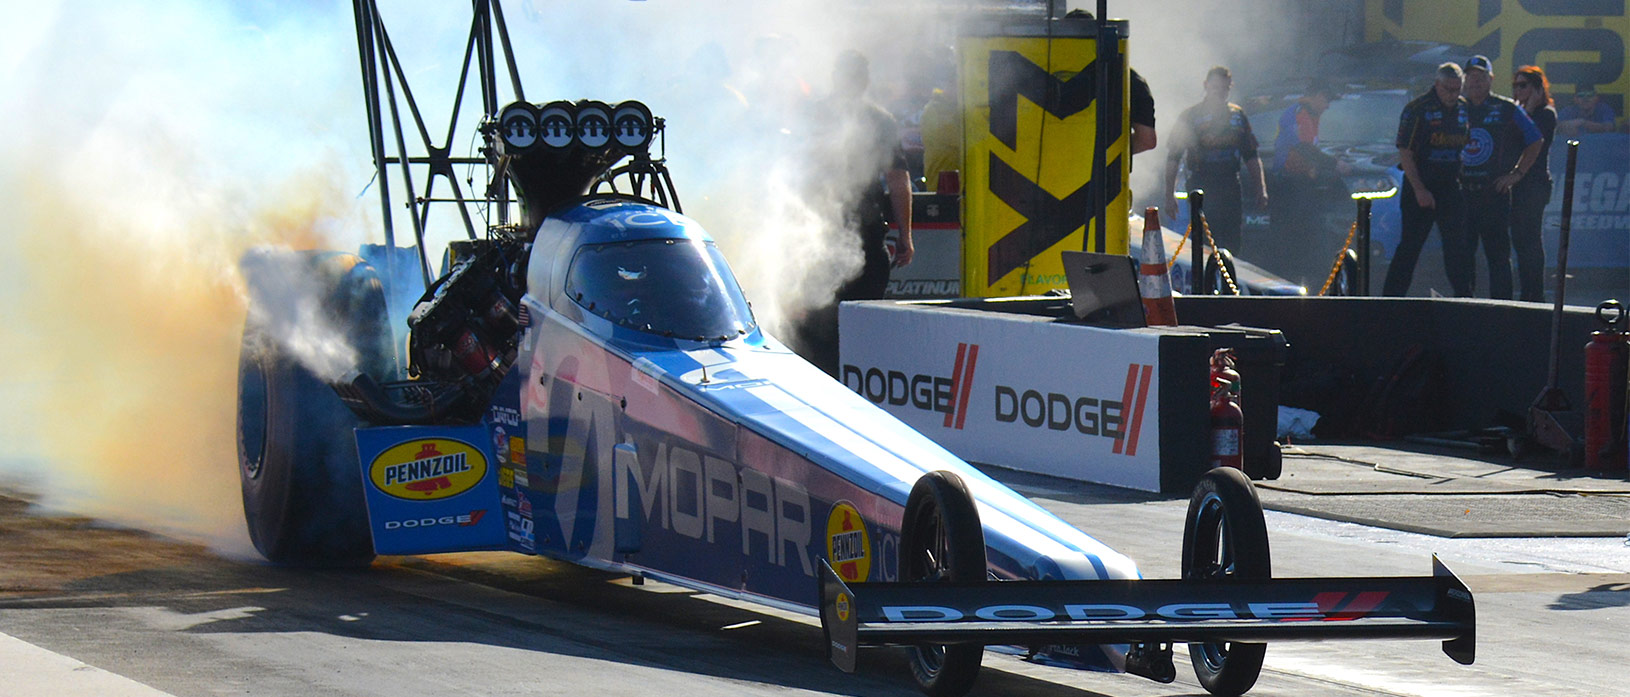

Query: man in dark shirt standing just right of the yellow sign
1165;65;1268;254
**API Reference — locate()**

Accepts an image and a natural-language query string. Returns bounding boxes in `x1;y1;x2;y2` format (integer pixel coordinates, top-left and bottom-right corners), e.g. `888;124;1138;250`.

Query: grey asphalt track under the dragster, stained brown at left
0;477;1630;697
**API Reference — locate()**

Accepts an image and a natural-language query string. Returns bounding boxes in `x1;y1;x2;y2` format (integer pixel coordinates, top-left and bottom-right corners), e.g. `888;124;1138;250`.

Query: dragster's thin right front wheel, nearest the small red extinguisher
1183;467;1273;697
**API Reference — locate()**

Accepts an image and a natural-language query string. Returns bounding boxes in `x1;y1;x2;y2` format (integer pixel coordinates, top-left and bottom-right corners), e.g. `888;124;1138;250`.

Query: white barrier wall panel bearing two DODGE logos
838;303;1161;492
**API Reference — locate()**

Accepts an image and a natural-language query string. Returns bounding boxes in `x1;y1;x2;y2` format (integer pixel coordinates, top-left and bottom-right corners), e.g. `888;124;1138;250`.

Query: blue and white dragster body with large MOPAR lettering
357;199;1138;668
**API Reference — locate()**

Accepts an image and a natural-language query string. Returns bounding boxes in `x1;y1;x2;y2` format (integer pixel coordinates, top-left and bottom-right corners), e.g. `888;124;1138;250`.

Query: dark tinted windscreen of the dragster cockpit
566;239;753;340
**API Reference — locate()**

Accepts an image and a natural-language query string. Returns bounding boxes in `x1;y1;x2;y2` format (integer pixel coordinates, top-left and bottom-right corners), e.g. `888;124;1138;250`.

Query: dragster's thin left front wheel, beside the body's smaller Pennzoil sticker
898;471;986;697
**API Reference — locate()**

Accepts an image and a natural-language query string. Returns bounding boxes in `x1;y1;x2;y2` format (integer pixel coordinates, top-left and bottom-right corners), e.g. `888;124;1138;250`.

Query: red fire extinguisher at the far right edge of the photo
1584;300;1630;469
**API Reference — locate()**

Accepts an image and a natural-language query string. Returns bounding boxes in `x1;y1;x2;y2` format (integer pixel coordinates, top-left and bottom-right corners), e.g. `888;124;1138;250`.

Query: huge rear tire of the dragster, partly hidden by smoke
238;252;390;567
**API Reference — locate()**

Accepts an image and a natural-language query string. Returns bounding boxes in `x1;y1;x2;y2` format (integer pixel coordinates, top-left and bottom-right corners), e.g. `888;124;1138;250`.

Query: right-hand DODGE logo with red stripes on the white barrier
996;363;1154;456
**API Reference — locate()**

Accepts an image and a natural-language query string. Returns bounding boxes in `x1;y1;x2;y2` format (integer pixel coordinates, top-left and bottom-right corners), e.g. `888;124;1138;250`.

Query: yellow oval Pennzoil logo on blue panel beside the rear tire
368;438;487;502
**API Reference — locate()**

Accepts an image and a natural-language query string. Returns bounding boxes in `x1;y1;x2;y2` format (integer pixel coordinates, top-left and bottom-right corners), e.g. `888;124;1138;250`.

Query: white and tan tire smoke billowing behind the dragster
0;0;1349;550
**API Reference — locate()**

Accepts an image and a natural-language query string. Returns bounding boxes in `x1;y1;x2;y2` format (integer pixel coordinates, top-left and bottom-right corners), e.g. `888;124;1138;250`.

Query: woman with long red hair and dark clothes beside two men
1511;65;1557;303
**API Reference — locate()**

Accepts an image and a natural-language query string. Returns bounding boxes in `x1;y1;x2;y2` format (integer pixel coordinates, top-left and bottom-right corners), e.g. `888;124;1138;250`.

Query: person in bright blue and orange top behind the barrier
1263;80;1351;283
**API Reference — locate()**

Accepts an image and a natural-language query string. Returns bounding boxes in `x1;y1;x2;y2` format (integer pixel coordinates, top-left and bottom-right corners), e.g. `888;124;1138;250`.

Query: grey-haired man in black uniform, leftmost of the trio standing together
1382;64;1472;298
